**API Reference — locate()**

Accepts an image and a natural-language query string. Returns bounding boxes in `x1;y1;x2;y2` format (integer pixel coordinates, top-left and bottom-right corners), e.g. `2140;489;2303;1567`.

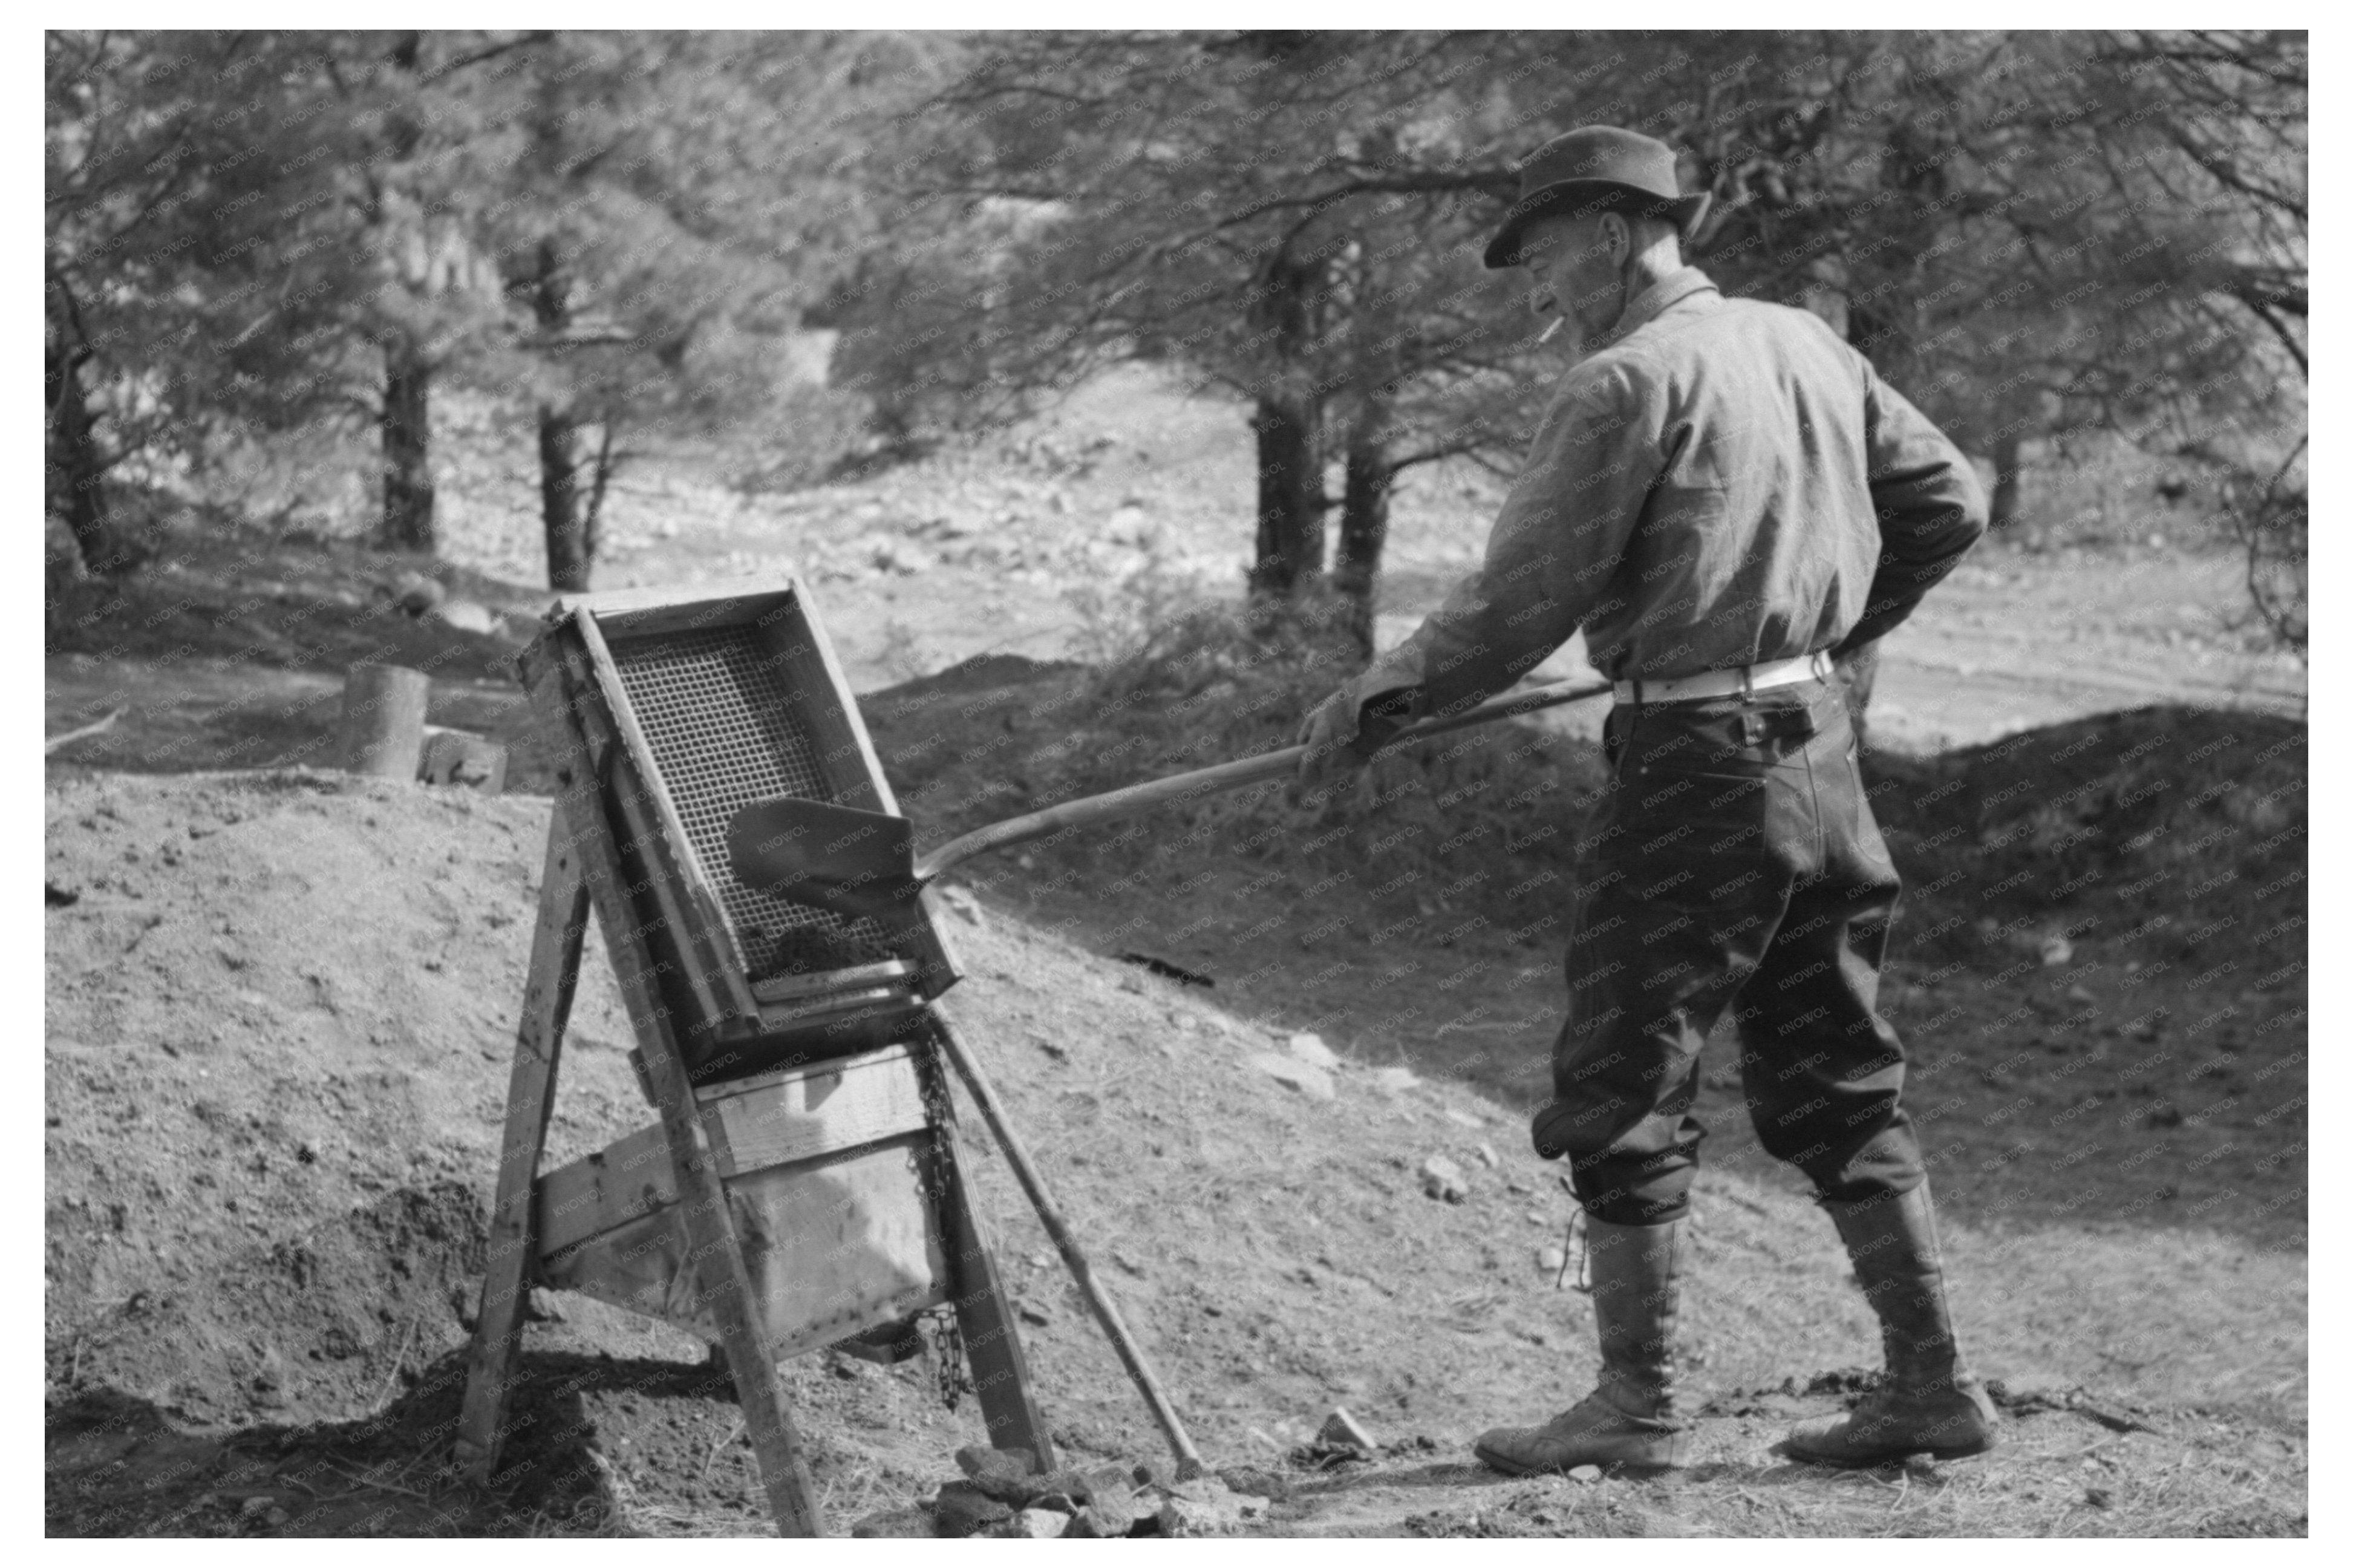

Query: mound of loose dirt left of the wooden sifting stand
45;773;642;1425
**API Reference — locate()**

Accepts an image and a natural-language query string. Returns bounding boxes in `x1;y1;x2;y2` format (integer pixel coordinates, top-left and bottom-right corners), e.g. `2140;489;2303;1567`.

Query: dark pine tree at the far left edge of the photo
42;31;344;572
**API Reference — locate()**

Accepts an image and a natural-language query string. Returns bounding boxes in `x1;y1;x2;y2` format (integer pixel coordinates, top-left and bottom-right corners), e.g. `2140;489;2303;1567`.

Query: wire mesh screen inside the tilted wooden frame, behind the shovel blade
612;626;894;982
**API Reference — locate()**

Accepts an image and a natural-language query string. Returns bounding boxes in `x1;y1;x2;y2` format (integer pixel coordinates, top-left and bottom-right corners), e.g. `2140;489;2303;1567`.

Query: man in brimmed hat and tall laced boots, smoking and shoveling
1301;127;1996;1474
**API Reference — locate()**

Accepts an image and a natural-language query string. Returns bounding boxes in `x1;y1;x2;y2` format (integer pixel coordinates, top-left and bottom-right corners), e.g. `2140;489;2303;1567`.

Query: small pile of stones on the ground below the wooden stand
849;1446;1285;1540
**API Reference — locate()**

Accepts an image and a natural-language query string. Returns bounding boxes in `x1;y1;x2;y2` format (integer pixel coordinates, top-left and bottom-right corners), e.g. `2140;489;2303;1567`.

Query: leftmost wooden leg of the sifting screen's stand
457;800;589;1483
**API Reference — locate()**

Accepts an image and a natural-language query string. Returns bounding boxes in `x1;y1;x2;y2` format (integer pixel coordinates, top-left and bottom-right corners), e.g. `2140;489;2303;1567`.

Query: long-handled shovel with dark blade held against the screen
727;681;1610;923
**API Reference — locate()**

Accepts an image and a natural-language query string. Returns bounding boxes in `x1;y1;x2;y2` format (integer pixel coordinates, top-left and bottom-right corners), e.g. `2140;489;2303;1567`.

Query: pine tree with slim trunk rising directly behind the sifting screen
475;33;936;591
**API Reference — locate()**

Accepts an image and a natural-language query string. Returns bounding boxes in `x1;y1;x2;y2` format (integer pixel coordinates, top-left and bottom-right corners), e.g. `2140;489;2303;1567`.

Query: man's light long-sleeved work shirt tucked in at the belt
1356;266;1986;723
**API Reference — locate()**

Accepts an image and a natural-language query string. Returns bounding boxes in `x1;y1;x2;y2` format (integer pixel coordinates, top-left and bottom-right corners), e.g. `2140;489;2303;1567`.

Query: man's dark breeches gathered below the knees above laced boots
1534;681;1920;1224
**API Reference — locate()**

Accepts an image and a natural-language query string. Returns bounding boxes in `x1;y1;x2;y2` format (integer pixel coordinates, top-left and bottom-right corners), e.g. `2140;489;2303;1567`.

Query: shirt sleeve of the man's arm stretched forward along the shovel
1358;362;1659;723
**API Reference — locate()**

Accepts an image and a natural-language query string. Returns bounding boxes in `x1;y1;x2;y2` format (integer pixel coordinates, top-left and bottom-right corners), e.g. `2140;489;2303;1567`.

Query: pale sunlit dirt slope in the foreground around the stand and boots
45;773;2303;1535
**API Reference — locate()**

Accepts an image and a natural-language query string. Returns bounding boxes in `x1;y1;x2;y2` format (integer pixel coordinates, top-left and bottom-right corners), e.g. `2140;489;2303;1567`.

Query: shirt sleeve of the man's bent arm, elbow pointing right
1838;356;1986;655
